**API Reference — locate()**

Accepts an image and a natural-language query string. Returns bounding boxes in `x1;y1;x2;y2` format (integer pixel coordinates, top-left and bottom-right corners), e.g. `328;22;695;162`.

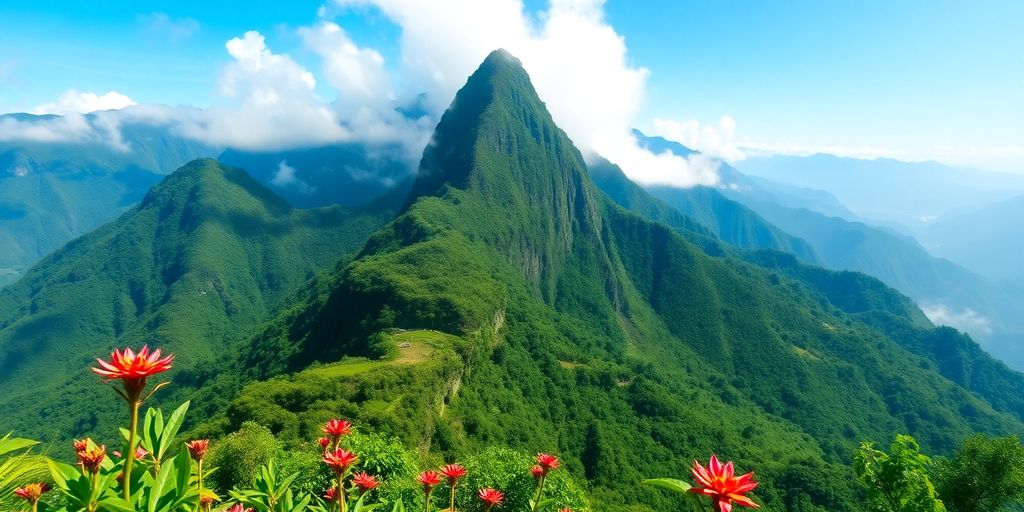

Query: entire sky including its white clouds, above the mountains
0;0;1024;174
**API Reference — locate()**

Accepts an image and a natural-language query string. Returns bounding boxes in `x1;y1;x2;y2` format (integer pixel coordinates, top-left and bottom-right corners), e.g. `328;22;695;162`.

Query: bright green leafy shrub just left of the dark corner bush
853;435;946;512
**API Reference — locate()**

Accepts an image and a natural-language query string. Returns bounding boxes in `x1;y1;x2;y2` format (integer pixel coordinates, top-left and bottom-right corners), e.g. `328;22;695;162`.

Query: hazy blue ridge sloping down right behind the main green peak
622;132;1024;369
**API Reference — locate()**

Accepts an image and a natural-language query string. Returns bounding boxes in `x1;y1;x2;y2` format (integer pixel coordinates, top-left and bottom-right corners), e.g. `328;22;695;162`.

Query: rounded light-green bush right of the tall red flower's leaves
208;422;281;492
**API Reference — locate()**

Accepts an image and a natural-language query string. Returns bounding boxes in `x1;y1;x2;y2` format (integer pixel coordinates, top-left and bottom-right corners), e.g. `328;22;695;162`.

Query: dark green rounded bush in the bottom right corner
933;434;1024;512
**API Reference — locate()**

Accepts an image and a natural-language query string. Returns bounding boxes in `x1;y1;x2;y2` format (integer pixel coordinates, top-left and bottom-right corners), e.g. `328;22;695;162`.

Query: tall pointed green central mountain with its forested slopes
184;50;1024;511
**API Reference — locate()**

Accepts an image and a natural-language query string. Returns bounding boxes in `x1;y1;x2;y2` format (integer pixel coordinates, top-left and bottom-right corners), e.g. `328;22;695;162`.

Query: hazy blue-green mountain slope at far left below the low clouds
0;114;218;286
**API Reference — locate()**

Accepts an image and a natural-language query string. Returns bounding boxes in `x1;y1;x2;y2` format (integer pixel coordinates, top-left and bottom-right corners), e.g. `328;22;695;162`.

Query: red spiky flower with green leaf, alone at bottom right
644;455;759;512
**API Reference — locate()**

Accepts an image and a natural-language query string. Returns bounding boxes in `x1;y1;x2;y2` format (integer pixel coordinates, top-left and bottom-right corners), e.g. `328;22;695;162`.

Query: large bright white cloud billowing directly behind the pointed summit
336;0;717;186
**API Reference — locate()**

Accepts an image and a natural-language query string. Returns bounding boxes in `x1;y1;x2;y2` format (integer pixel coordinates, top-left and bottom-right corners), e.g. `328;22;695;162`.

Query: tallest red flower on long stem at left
92;345;174;501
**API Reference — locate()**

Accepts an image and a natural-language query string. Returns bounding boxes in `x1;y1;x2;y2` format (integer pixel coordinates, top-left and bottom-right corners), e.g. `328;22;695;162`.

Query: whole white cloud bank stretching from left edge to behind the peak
0;0;731;186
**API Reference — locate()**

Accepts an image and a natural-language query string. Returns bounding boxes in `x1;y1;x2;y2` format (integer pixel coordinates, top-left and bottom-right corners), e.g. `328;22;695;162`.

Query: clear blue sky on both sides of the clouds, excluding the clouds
0;0;1024;171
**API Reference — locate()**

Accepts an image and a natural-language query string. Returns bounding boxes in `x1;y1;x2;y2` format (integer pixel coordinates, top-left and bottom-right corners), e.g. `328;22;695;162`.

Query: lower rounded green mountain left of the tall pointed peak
0;160;390;439
